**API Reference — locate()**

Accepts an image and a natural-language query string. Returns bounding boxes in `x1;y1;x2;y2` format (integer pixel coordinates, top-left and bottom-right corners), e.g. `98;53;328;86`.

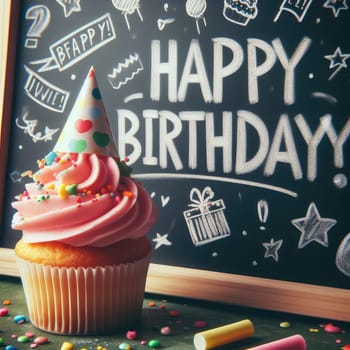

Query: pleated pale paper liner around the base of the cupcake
17;255;150;335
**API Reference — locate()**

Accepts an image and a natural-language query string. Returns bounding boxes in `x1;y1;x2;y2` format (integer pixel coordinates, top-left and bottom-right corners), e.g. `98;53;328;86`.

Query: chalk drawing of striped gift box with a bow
183;186;231;246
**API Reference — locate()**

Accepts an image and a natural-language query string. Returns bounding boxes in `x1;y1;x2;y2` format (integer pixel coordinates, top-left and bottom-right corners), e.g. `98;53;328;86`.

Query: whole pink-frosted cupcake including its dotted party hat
12;68;157;335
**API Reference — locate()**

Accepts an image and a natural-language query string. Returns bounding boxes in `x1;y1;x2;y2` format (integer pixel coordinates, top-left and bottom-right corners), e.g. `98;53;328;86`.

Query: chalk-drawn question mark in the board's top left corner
24;5;51;49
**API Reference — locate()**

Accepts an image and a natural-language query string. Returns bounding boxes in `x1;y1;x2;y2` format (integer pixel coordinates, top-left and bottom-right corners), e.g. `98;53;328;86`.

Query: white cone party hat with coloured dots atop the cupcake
53;67;118;157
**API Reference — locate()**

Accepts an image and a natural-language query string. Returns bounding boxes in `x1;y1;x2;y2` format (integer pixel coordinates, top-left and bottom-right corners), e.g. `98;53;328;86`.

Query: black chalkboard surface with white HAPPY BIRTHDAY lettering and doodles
0;0;350;317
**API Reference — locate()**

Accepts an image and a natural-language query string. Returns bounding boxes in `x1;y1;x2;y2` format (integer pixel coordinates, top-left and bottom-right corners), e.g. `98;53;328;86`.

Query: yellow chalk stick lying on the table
193;320;254;350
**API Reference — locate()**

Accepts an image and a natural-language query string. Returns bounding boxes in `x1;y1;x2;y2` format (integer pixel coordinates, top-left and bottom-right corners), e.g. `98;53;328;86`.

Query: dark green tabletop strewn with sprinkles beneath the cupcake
0;276;350;350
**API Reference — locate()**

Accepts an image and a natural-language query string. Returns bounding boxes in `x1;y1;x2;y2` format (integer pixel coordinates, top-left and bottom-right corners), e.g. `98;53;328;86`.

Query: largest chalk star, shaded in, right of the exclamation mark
291;203;337;249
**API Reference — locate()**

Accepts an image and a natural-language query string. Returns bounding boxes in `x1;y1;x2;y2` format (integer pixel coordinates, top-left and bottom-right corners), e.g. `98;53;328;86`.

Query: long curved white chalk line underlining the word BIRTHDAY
133;173;298;198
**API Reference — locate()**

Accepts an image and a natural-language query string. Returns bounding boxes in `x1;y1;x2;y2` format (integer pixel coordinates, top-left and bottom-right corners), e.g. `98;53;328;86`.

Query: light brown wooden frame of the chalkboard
0;0;350;321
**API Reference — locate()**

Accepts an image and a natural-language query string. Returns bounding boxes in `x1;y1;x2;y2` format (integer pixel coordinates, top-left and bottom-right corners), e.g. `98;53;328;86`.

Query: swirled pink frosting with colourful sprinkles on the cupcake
12;153;157;247
